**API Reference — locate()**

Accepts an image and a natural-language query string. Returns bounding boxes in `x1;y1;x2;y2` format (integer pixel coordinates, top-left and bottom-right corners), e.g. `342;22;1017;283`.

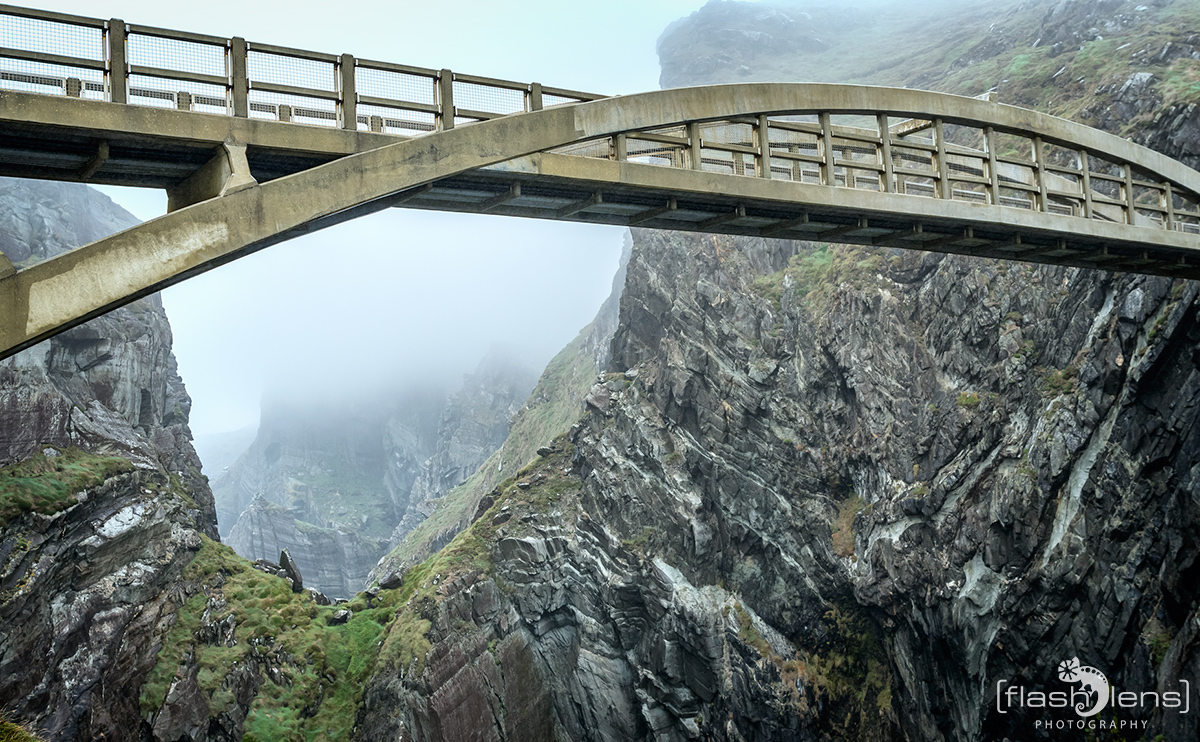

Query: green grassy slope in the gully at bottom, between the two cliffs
140;537;398;742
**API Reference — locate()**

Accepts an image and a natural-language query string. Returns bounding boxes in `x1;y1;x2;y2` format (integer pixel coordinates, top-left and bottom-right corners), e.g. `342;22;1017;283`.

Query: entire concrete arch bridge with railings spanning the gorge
0;6;1200;358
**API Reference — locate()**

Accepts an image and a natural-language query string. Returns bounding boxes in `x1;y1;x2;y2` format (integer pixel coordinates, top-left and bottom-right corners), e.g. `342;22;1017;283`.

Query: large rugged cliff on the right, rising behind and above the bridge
359;1;1200;740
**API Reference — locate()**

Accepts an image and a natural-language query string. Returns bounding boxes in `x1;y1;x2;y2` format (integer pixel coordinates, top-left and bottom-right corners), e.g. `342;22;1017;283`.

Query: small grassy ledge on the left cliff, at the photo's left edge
0;448;133;527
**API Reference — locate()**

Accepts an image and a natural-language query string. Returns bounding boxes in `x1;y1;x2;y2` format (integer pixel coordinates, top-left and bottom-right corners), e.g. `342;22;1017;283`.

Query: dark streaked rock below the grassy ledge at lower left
0;469;204;740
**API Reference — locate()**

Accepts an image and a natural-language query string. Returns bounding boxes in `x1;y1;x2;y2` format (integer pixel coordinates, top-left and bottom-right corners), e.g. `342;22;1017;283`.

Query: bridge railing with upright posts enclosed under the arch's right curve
558;110;1200;234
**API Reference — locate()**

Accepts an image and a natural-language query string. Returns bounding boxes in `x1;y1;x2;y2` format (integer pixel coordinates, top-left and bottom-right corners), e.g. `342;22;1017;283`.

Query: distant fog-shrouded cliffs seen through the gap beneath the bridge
214;352;536;598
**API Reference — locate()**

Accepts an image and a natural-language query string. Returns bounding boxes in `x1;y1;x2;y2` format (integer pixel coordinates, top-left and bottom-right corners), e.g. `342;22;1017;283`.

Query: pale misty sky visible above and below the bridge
30;0;704;436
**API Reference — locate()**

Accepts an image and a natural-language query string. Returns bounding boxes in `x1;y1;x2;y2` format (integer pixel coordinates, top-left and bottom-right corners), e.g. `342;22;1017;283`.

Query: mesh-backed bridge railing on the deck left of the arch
0;5;604;136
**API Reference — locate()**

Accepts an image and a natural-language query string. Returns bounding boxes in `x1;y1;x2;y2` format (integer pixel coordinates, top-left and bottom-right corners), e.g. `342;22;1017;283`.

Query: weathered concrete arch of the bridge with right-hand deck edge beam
0;83;1200;357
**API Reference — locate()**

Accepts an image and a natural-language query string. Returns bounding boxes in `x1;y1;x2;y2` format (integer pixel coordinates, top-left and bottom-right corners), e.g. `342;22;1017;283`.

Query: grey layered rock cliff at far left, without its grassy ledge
0;179;216;740
